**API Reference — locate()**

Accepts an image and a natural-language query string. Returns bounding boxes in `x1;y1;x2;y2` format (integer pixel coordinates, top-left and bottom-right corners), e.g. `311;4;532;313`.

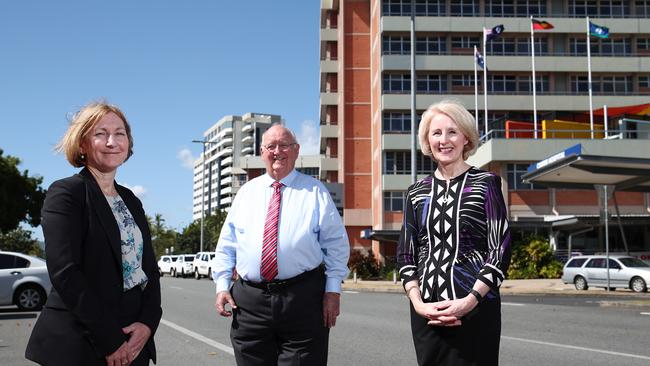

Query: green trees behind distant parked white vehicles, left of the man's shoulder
174;210;226;253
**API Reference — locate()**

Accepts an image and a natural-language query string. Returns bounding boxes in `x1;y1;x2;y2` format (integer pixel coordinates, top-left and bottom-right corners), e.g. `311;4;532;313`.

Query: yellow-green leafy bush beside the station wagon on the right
508;235;562;279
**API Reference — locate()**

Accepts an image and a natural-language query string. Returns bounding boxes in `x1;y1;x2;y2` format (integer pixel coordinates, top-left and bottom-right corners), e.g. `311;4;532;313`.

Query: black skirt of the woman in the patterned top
409;297;501;366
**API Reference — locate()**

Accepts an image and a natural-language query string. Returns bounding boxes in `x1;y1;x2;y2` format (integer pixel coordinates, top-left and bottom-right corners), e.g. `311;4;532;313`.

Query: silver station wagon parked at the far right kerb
562;255;650;292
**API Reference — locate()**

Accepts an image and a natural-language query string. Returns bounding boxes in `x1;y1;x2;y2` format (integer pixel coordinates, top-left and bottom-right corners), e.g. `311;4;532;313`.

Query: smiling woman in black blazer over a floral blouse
25;103;162;366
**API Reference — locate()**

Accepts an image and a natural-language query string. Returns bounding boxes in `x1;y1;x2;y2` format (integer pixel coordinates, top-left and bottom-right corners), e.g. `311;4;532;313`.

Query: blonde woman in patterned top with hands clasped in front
397;101;511;366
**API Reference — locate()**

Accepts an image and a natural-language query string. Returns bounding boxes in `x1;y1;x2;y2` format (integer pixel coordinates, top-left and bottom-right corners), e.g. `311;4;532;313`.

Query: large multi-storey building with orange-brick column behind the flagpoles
320;0;650;258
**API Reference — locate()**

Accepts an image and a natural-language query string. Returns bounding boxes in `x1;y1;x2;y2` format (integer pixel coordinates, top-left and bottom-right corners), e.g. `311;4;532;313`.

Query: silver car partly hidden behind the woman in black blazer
0;252;52;310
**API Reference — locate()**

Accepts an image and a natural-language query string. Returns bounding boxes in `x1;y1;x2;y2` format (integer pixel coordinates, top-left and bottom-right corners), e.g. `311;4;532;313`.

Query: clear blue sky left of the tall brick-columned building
0;0;320;237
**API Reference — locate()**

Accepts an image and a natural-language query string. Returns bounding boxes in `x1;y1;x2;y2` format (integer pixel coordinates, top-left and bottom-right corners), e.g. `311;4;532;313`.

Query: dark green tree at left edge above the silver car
0;149;45;233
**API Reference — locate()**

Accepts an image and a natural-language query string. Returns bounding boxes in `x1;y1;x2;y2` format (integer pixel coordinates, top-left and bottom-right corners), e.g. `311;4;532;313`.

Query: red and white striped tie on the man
260;181;282;281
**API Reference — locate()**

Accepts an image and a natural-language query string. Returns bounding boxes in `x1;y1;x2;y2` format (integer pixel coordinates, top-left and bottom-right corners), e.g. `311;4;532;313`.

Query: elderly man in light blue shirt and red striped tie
213;125;350;366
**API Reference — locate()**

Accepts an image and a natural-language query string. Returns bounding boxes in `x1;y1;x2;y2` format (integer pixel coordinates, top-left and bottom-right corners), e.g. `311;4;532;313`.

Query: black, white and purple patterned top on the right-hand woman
397;168;511;302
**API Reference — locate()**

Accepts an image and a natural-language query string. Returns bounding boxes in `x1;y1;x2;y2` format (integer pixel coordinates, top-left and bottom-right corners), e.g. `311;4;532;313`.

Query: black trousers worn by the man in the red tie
230;269;329;366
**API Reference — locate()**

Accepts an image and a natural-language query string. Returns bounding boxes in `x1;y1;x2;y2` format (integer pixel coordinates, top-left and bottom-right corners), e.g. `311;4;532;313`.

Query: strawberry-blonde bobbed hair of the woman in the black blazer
56;102;133;168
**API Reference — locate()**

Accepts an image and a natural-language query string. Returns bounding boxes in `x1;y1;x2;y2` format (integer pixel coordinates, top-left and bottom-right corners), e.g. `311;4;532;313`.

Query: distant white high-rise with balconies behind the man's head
192;113;321;220
